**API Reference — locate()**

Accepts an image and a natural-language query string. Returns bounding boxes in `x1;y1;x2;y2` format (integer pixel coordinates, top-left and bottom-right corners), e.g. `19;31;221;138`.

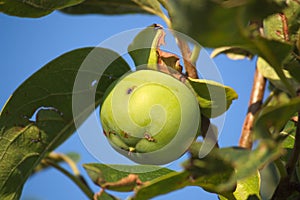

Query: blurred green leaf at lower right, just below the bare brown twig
188;140;283;194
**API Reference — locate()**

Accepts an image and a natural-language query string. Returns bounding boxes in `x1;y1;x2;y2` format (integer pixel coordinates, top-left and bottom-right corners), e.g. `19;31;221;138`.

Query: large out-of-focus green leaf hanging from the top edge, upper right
168;0;295;95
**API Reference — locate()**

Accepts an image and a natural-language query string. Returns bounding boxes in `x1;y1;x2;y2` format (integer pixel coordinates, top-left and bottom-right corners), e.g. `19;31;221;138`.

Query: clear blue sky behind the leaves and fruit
0;9;254;200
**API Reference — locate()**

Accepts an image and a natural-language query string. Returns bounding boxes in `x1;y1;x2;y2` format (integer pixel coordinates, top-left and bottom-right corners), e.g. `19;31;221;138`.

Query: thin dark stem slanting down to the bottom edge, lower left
43;158;94;199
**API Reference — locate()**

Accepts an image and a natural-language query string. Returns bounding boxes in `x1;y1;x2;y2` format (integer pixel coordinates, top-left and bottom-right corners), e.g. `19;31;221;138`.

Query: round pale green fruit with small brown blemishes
100;70;201;164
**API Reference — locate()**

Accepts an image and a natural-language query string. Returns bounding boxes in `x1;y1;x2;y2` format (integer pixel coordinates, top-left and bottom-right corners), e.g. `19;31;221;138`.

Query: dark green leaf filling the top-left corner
0;0;84;17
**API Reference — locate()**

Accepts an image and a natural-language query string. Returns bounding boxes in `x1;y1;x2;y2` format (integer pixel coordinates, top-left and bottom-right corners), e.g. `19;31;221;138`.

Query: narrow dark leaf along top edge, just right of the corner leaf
61;0;152;15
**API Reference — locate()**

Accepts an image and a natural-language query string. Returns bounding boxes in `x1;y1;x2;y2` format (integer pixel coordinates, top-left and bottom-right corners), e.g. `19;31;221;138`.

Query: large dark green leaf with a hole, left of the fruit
0;48;129;199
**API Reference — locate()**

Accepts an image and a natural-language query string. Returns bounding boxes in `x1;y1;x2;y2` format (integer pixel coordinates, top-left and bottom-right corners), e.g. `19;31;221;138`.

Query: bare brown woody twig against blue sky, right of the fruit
239;68;266;149
